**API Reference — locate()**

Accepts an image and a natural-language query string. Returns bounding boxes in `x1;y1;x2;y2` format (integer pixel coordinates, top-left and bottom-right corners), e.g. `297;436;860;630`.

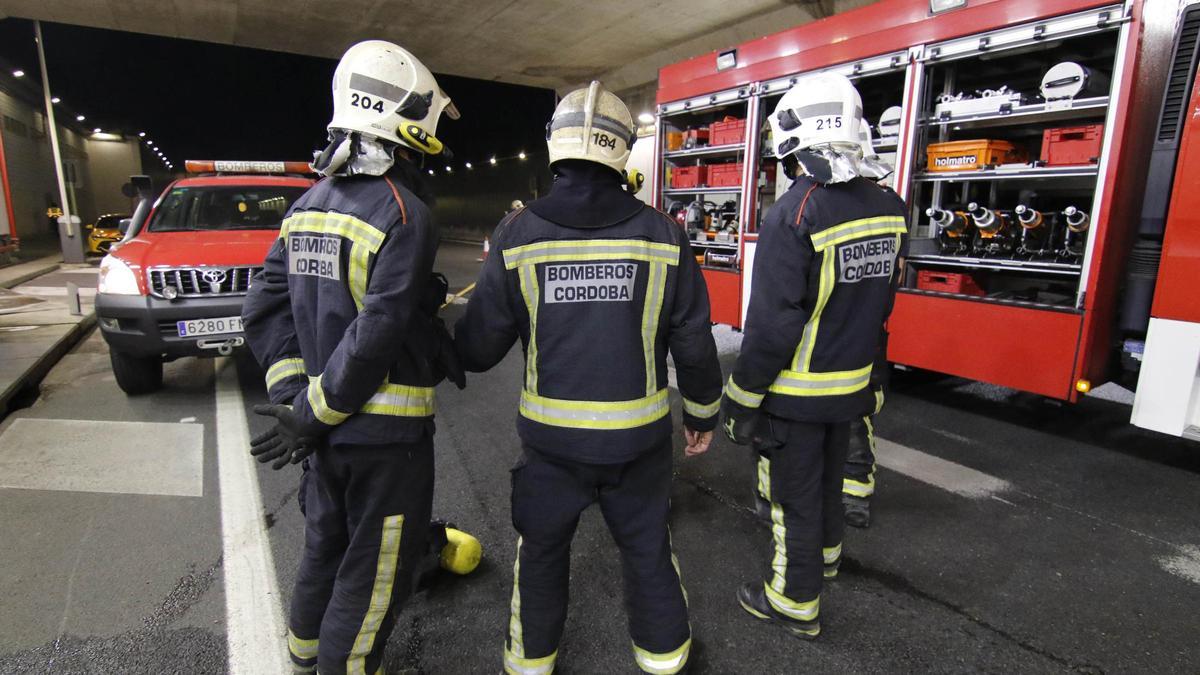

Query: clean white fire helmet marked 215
768;73;863;159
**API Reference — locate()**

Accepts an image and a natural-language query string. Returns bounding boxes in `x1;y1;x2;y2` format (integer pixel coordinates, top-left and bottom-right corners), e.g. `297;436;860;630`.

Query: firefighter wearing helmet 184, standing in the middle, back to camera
455;82;721;675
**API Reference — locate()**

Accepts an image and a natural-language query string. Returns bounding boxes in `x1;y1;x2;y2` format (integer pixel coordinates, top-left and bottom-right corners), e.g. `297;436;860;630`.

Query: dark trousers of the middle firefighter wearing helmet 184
504;440;691;675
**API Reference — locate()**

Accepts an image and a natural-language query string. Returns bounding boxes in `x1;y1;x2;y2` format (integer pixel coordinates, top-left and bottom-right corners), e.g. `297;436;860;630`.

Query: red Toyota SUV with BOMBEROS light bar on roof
96;161;313;394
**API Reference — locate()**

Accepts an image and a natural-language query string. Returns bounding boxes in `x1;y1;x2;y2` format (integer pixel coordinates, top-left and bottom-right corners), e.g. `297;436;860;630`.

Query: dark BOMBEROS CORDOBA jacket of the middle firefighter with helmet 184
455;161;721;464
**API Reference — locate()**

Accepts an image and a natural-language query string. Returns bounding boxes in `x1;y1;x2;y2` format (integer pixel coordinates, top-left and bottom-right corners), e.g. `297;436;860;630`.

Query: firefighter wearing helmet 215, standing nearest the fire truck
722;74;907;639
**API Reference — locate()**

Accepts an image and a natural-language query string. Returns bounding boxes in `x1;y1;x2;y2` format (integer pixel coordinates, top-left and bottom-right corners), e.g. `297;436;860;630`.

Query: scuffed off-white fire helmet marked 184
546;82;637;173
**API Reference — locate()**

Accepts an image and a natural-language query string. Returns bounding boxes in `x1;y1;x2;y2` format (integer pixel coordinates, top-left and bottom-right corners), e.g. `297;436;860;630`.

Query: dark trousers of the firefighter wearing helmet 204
288;436;433;675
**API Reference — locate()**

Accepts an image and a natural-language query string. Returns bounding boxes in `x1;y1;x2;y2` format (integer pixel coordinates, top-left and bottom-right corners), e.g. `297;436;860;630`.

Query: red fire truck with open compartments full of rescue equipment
653;0;1200;437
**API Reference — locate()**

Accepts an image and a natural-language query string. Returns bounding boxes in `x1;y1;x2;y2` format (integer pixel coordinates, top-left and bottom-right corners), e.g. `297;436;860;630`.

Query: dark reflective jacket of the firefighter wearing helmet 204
242;161;438;444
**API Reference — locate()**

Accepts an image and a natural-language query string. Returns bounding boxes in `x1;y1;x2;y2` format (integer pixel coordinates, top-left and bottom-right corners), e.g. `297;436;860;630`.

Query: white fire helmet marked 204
329;40;458;155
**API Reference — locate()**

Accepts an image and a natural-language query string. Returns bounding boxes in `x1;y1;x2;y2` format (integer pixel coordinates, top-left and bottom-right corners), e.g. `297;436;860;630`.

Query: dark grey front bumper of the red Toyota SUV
96;293;245;358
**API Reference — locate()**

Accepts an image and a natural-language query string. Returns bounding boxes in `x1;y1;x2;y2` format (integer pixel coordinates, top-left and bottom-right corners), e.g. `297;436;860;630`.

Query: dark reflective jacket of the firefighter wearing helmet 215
725;172;907;422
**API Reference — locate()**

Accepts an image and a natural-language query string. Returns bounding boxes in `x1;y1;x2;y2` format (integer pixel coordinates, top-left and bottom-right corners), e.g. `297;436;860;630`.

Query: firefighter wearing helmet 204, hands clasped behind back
244;41;462;675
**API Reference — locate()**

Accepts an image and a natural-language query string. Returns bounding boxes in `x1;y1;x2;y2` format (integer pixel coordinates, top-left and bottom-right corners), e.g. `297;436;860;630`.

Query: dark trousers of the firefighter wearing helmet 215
755;416;850;622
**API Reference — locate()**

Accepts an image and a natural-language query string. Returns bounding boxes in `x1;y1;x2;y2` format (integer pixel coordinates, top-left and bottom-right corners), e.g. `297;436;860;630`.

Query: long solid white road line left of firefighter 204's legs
216;358;290;675
